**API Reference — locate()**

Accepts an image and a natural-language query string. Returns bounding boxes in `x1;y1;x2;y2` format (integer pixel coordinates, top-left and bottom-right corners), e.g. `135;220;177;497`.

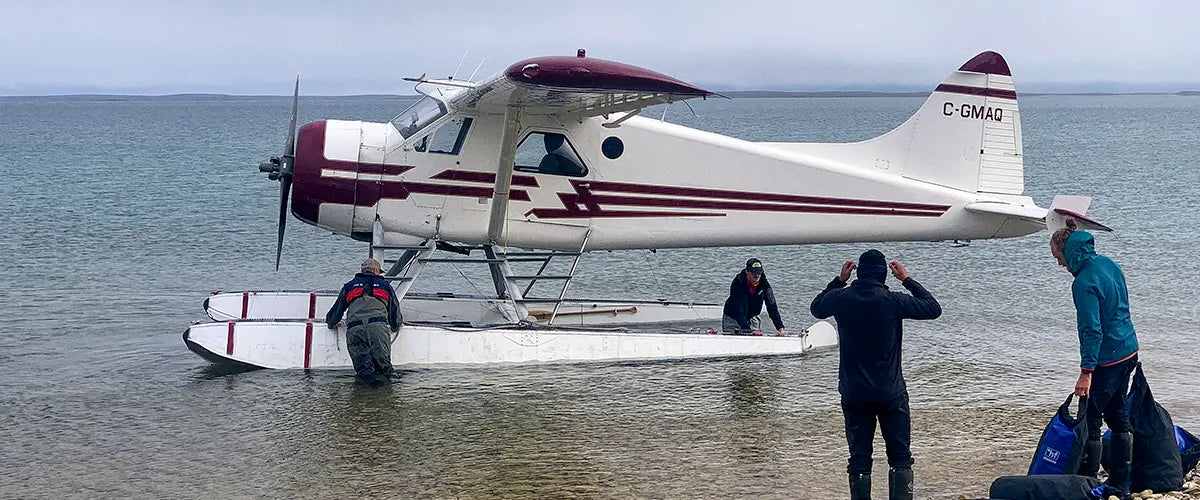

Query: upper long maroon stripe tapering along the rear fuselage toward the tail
571;180;950;212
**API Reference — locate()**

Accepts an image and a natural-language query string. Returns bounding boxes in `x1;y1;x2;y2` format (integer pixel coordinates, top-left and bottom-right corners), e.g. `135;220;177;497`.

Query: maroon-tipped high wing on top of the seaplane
450;53;714;118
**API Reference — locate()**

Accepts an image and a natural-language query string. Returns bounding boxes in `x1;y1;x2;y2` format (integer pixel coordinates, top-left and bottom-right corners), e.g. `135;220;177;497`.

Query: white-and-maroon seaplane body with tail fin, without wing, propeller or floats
292;53;1044;251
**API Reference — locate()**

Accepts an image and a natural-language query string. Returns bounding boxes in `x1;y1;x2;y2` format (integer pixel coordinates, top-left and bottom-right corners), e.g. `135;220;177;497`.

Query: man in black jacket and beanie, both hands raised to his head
811;249;942;500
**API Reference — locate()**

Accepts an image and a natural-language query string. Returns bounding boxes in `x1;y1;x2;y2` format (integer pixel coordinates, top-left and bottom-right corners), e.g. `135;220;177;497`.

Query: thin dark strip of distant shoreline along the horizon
0;90;1200;102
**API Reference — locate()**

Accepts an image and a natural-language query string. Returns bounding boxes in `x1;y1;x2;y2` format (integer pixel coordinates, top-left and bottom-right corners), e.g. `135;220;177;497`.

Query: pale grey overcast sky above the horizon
0;0;1200;95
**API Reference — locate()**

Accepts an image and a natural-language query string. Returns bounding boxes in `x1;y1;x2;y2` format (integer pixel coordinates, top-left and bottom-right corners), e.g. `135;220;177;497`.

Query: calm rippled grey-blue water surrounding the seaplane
0;96;1200;499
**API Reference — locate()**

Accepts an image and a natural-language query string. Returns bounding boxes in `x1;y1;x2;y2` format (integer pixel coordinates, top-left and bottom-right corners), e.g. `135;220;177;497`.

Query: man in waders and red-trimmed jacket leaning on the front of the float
325;259;404;385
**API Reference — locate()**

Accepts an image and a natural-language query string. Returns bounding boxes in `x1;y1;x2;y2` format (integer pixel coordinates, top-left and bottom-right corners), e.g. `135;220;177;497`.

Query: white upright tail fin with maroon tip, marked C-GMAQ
780;50;1025;194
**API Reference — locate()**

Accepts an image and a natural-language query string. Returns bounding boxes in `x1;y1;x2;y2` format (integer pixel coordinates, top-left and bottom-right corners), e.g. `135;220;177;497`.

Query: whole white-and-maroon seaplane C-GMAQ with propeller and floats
184;49;1109;369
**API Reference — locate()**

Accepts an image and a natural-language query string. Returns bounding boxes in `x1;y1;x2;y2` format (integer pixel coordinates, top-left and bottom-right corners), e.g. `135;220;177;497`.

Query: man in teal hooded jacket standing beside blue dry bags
1050;221;1138;493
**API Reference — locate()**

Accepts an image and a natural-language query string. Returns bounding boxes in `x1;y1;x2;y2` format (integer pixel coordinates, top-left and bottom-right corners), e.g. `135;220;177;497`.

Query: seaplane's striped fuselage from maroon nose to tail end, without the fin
293;110;1042;249
